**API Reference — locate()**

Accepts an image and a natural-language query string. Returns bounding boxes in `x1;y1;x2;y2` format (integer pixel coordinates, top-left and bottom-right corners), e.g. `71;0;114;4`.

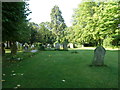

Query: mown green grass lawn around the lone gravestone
3;50;118;88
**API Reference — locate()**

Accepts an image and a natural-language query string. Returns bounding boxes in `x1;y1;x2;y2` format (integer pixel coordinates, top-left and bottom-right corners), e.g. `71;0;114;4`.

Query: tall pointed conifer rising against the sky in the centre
50;5;67;42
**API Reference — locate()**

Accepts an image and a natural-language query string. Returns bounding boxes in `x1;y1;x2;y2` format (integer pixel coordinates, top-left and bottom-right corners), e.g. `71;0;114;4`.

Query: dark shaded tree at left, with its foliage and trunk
2;2;30;54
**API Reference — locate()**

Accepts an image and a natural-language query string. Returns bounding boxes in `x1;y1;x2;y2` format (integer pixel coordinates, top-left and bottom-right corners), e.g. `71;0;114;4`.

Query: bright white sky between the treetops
28;0;81;26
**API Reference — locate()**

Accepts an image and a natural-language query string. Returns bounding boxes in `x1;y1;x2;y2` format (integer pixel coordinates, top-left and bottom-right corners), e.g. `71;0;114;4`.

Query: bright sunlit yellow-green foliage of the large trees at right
67;2;120;45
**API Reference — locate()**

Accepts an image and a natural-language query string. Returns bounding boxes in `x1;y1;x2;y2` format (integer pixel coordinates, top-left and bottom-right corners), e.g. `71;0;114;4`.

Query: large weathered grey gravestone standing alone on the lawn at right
92;46;106;66
